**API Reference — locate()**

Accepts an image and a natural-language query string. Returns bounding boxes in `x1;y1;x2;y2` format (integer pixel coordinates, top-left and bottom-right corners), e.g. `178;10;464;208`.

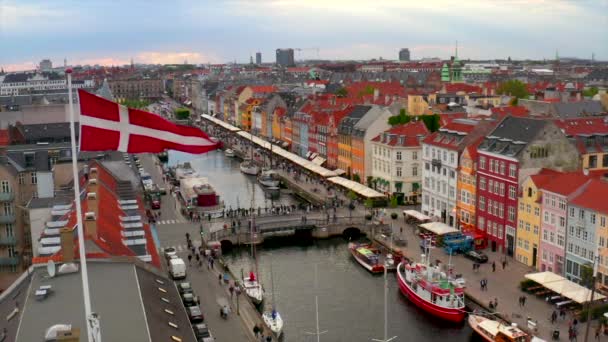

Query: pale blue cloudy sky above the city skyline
0;0;608;70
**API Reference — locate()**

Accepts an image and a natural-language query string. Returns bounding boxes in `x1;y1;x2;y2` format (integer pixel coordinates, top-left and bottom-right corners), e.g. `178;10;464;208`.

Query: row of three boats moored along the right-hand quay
349;243;533;342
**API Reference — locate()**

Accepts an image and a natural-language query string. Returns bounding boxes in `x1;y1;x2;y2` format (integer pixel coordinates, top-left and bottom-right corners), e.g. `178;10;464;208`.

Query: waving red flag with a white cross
78;89;219;153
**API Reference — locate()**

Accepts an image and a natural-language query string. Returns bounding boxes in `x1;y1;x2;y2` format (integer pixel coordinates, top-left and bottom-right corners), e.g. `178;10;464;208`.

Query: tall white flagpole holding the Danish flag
65;68;101;342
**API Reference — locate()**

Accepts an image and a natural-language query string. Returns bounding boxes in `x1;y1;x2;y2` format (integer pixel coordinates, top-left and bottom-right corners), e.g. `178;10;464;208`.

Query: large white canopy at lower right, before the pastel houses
525;272;606;304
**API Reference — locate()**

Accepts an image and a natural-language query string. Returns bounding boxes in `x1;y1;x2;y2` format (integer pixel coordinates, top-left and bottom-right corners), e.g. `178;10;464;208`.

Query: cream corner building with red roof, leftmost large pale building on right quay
366;121;429;204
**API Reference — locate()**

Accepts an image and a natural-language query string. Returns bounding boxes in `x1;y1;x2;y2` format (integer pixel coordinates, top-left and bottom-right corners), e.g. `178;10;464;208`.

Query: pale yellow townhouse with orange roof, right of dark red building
507;169;557;268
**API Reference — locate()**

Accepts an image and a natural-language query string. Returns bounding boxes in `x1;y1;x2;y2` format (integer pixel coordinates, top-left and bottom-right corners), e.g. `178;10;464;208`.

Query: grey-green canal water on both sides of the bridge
170;152;480;342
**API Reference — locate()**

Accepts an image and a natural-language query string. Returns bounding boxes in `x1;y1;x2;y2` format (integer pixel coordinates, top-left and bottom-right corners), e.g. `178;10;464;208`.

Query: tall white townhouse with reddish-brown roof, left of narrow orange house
422;119;493;227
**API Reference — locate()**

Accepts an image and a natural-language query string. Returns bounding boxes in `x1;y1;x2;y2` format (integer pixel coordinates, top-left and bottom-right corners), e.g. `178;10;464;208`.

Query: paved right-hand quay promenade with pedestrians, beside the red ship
387;210;597;341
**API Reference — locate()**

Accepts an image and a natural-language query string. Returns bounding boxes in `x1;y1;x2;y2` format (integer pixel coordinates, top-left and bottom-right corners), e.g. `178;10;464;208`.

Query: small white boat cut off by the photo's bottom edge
468;314;531;342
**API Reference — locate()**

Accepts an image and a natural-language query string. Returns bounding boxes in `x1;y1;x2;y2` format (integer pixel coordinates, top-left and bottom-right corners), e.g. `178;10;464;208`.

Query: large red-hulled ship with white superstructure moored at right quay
397;239;466;323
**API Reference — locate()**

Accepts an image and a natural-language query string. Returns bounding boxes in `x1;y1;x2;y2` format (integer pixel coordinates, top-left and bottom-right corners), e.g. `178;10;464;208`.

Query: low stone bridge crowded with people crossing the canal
204;215;389;247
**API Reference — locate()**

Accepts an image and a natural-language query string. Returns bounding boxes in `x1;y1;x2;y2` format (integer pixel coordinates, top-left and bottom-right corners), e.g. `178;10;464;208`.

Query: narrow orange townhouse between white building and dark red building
456;138;483;234
